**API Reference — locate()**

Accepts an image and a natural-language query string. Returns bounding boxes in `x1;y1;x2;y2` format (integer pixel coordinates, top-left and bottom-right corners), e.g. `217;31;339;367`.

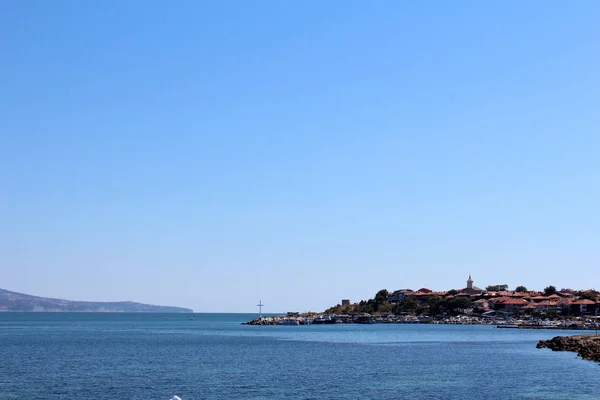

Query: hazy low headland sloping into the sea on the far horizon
0;289;193;313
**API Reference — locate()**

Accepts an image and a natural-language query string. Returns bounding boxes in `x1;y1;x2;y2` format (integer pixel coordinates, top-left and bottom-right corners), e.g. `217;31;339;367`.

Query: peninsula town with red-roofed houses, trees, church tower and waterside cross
245;275;600;330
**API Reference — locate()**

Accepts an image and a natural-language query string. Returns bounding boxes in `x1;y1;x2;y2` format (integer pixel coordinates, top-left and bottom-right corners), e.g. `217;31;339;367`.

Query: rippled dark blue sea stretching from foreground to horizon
0;313;600;400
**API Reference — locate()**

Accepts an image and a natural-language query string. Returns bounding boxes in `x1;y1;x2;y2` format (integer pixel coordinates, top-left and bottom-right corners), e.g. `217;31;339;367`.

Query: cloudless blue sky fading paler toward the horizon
0;0;600;312
